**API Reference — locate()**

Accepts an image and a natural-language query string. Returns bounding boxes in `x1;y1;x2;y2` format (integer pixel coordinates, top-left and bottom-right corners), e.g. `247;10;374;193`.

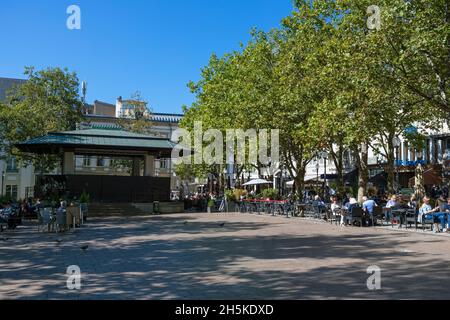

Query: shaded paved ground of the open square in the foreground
0;214;450;300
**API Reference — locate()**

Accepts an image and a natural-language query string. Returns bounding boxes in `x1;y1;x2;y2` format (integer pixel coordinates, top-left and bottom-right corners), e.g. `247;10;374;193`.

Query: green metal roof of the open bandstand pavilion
17;129;174;153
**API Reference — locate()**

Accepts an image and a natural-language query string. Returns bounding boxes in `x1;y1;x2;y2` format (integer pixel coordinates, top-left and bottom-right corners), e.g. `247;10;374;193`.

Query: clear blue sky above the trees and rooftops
0;0;292;113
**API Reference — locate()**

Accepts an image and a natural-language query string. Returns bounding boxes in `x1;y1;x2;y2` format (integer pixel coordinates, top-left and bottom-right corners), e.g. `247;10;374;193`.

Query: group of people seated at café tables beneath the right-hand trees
326;195;450;232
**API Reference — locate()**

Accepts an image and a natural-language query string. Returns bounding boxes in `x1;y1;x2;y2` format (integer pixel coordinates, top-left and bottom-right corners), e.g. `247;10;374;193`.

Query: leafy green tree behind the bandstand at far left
0;67;82;172
